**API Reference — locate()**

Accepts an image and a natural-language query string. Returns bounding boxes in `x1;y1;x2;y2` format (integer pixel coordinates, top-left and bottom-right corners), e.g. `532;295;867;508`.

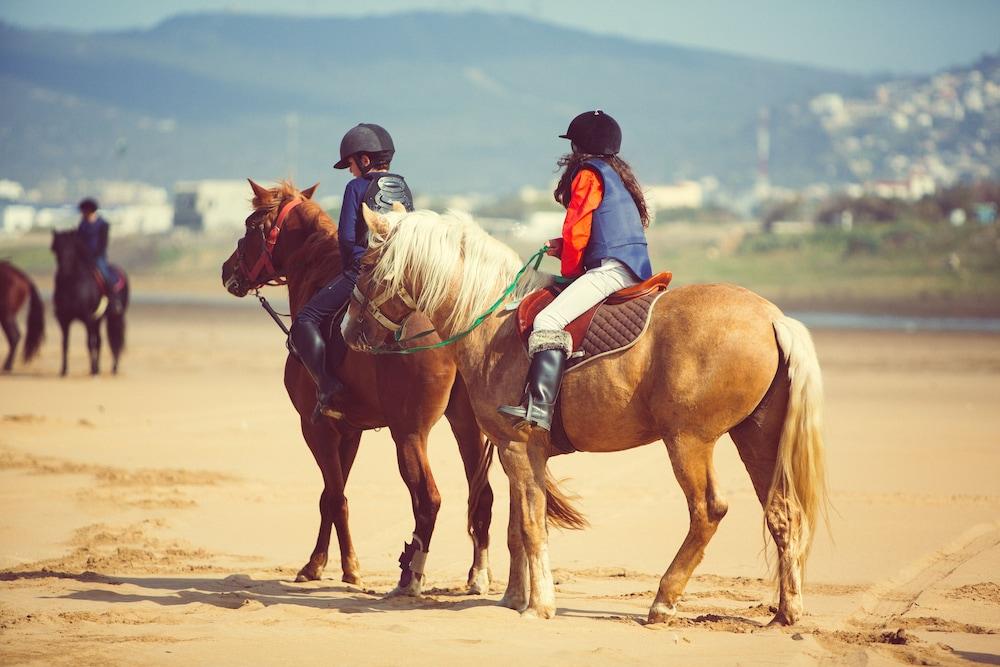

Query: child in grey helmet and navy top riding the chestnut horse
289;123;413;414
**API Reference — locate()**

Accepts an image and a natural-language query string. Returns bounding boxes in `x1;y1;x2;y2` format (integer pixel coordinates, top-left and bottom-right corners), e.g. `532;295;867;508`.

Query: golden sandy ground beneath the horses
0;304;1000;665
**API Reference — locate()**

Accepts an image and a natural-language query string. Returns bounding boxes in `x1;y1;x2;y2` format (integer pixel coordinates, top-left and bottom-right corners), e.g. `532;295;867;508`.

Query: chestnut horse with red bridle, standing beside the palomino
222;181;493;595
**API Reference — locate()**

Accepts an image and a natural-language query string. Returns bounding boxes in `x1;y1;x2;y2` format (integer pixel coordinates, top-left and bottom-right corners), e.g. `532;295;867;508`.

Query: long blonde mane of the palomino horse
369;211;551;335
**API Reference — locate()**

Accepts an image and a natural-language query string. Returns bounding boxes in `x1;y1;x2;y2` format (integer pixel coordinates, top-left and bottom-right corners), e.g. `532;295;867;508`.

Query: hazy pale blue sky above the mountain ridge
0;0;1000;72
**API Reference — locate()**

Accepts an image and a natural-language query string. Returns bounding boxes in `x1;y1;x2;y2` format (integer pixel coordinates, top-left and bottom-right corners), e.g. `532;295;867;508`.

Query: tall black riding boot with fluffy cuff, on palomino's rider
497;330;573;431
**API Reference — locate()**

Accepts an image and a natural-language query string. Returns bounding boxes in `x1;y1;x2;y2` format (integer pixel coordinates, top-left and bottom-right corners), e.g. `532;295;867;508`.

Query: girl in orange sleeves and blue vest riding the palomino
498;110;652;431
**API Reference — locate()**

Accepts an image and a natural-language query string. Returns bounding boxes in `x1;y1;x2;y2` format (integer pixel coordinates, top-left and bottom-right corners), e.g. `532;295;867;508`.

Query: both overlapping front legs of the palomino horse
501;438;556;618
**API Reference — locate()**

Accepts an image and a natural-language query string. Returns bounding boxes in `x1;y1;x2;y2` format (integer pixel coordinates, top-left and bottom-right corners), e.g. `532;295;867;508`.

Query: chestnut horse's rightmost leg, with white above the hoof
445;376;493;595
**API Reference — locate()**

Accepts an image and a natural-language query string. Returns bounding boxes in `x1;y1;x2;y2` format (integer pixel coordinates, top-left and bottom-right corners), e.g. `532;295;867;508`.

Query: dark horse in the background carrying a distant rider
52;230;129;375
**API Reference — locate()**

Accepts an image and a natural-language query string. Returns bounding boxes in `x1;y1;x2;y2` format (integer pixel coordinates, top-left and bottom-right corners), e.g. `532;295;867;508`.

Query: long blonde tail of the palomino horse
764;316;828;567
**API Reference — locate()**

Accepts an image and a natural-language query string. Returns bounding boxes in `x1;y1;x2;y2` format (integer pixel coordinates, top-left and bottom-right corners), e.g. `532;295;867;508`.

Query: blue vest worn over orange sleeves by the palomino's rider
574;160;653;280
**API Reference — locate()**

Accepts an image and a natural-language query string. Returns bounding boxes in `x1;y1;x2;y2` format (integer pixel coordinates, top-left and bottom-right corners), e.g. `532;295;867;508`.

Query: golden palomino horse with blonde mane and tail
344;211;826;624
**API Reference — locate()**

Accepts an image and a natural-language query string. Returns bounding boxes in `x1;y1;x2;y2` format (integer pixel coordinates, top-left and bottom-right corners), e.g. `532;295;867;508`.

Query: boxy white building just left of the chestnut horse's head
174;180;252;232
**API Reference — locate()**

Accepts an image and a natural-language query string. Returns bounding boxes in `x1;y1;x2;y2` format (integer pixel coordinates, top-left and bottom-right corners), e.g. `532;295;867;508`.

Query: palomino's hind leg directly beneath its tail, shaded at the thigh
729;365;802;625
